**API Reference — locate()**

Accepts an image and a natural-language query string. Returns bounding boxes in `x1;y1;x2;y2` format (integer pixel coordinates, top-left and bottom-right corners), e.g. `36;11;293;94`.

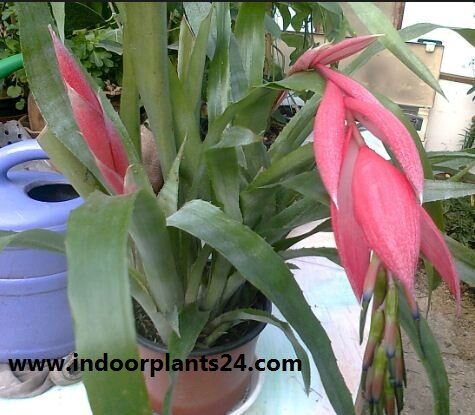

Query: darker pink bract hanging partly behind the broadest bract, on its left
331;140;370;301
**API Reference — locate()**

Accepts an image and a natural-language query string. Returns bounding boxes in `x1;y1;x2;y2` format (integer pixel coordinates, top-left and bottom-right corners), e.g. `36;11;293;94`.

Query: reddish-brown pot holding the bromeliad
138;303;270;415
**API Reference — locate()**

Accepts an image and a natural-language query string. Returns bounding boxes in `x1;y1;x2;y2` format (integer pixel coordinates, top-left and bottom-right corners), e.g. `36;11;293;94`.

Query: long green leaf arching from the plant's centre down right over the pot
167;200;354;415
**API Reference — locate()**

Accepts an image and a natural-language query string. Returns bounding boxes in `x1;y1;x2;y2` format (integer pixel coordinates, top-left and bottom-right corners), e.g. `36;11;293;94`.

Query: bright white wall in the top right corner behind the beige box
402;2;475;151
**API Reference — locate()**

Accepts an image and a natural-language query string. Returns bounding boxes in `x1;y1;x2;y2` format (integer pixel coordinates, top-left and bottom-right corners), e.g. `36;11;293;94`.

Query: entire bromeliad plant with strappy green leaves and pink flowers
7;2;475;415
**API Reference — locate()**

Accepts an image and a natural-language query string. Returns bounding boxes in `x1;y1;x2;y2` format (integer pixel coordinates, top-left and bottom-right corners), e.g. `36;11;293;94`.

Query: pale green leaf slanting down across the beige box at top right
348;2;444;96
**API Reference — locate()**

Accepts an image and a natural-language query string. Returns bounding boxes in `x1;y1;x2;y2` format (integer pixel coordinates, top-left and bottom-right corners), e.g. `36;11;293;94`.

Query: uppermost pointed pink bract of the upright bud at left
49;26;100;111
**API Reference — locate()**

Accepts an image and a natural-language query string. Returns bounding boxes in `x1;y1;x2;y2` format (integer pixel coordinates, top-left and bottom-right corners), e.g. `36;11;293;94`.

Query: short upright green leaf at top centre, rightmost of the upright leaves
234;2;267;87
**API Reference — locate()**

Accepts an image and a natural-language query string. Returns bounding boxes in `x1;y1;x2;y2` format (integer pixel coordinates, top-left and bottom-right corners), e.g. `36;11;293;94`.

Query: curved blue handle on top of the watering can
0;140;49;180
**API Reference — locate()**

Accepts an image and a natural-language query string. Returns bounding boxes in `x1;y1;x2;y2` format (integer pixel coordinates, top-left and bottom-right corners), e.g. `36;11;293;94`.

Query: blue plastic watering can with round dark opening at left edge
0;140;82;362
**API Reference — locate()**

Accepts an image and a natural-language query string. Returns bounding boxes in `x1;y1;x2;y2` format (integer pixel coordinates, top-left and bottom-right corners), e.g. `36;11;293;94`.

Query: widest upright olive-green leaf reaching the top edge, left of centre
124;2;177;178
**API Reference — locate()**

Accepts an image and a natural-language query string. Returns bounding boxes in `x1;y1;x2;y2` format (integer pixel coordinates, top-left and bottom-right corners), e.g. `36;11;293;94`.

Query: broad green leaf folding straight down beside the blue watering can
66;193;151;415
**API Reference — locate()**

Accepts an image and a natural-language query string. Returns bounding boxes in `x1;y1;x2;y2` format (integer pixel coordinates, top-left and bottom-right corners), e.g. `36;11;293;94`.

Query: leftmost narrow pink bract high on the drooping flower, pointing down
313;81;345;207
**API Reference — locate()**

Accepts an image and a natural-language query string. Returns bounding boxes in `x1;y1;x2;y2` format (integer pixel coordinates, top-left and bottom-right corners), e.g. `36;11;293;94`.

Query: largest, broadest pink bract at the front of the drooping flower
352;147;421;292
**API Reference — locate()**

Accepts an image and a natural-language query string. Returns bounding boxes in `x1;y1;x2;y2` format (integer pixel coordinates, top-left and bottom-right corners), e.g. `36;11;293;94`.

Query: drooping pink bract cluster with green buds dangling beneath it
290;36;460;414
